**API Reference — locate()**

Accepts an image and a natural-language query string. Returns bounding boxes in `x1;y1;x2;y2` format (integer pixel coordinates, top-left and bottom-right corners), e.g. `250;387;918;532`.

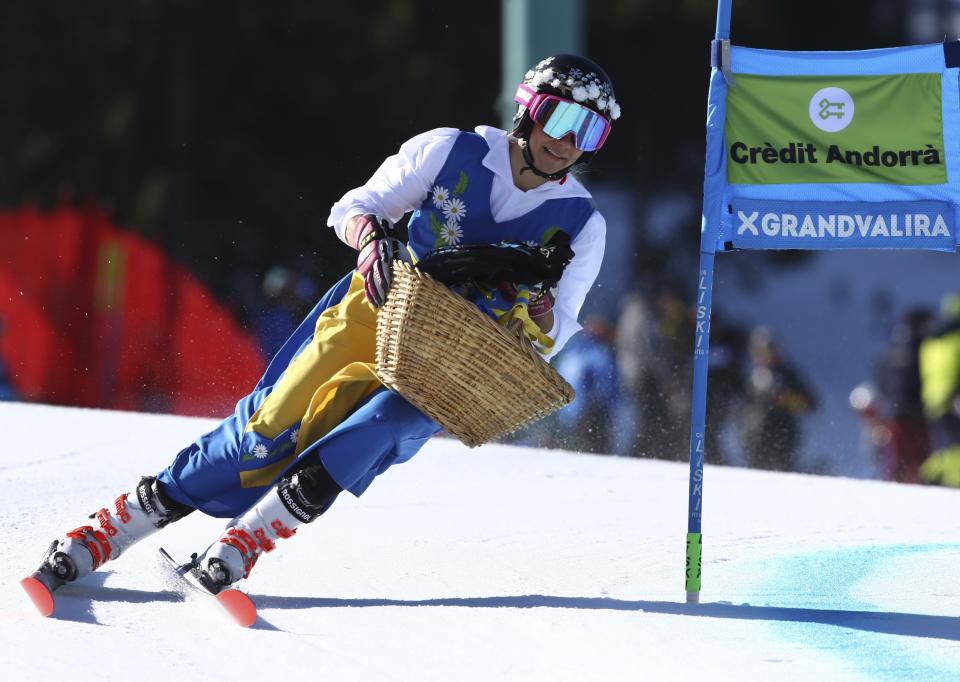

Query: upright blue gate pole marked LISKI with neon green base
686;0;733;603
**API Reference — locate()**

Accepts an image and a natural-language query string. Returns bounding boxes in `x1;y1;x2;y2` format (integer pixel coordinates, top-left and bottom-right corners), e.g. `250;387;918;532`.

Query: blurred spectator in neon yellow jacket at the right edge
920;293;960;488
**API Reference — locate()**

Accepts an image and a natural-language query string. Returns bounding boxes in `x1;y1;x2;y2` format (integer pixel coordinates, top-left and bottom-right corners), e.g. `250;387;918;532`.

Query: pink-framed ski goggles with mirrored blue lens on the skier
513;83;611;152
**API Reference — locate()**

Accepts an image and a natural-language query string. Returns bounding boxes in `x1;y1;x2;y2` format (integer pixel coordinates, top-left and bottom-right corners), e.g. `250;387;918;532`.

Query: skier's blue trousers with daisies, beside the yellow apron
157;274;440;518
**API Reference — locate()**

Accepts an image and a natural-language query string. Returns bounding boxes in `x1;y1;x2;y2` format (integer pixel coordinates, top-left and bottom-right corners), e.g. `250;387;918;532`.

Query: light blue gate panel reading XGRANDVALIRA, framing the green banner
701;43;960;253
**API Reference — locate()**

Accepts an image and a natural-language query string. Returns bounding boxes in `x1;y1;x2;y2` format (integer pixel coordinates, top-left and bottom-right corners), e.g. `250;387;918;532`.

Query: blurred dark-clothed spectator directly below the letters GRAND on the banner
741;327;815;471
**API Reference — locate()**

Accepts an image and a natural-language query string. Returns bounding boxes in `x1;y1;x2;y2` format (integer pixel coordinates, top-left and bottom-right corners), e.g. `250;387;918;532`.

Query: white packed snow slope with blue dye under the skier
0;403;960;682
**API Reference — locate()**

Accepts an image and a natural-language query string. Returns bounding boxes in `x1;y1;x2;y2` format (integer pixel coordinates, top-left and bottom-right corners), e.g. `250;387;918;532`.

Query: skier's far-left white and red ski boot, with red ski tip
20;476;193;616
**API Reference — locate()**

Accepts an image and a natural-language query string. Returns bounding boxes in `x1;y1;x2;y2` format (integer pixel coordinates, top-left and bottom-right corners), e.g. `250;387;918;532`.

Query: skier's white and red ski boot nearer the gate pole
195;465;342;594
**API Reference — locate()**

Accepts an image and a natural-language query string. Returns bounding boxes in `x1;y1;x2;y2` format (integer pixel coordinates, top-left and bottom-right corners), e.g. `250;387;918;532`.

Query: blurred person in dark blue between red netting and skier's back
254;265;317;359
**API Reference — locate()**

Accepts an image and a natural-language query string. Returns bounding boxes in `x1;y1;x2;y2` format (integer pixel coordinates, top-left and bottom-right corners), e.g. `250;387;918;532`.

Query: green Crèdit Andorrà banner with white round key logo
724;73;947;185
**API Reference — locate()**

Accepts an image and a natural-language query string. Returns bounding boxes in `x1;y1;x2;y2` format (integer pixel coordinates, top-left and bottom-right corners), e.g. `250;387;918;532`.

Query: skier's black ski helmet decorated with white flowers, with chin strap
513;54;620;180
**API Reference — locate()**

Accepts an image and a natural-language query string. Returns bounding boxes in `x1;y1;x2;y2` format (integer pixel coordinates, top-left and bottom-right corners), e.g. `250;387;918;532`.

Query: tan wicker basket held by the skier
377;262;574;447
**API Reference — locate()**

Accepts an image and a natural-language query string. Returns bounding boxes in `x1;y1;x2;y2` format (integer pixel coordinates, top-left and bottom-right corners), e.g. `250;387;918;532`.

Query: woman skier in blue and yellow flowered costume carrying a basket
26;54;620;593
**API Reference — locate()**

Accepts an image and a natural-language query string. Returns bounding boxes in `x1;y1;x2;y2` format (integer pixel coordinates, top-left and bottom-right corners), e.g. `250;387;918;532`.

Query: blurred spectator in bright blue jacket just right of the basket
556;315;620;453
